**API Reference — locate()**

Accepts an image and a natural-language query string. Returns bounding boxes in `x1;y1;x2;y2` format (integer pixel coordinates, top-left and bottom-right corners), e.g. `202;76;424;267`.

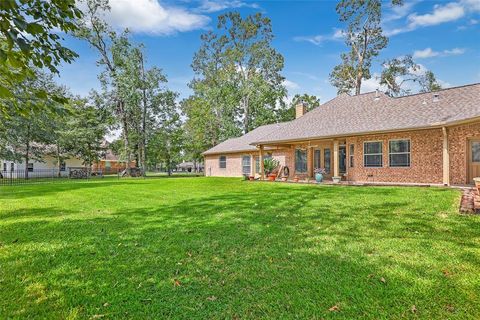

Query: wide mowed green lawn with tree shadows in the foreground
0;178;480;319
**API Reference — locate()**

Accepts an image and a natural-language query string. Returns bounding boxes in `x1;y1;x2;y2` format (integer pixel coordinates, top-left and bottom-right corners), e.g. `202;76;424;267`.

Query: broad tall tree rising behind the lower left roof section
191;12;286;140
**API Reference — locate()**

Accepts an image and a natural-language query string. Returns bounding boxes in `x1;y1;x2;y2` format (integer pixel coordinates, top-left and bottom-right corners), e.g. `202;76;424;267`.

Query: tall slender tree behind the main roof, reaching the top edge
330;0;403;95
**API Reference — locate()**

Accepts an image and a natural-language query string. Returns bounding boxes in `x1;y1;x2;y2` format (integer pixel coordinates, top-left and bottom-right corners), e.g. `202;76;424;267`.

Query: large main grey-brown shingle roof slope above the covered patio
253;83;480;145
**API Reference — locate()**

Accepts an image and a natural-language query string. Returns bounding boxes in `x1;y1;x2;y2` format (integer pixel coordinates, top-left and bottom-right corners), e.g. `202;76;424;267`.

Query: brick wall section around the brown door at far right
448;122;480;184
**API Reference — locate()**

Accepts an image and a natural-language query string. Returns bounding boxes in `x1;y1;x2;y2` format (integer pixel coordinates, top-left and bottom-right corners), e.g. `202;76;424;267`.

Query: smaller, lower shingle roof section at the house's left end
203;122;289;155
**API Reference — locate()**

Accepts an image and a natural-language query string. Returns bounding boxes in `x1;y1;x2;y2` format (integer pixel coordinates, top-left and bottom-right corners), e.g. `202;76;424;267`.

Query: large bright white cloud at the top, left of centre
101;0;210;35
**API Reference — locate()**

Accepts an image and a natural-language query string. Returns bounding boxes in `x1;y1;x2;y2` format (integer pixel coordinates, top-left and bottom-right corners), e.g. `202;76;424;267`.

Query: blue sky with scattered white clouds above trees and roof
59;0;480;103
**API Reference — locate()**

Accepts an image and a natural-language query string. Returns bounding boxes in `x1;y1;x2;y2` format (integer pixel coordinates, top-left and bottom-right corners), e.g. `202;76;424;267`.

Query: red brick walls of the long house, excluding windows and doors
205;122;480;185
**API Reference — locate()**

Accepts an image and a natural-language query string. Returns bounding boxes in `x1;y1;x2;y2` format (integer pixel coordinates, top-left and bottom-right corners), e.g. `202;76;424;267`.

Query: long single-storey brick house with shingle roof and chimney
204;84;480;185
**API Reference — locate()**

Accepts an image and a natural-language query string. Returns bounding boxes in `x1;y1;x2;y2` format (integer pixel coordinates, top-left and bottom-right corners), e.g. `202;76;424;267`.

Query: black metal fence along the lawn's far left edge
0;168;104;186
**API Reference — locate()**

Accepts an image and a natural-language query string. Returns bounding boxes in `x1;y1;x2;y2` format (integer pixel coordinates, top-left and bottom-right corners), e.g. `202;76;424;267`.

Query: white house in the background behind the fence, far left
0;155;84;178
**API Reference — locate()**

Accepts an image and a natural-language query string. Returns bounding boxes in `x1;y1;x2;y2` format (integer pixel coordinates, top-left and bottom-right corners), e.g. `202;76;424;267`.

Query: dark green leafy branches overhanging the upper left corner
0;0;82;114
